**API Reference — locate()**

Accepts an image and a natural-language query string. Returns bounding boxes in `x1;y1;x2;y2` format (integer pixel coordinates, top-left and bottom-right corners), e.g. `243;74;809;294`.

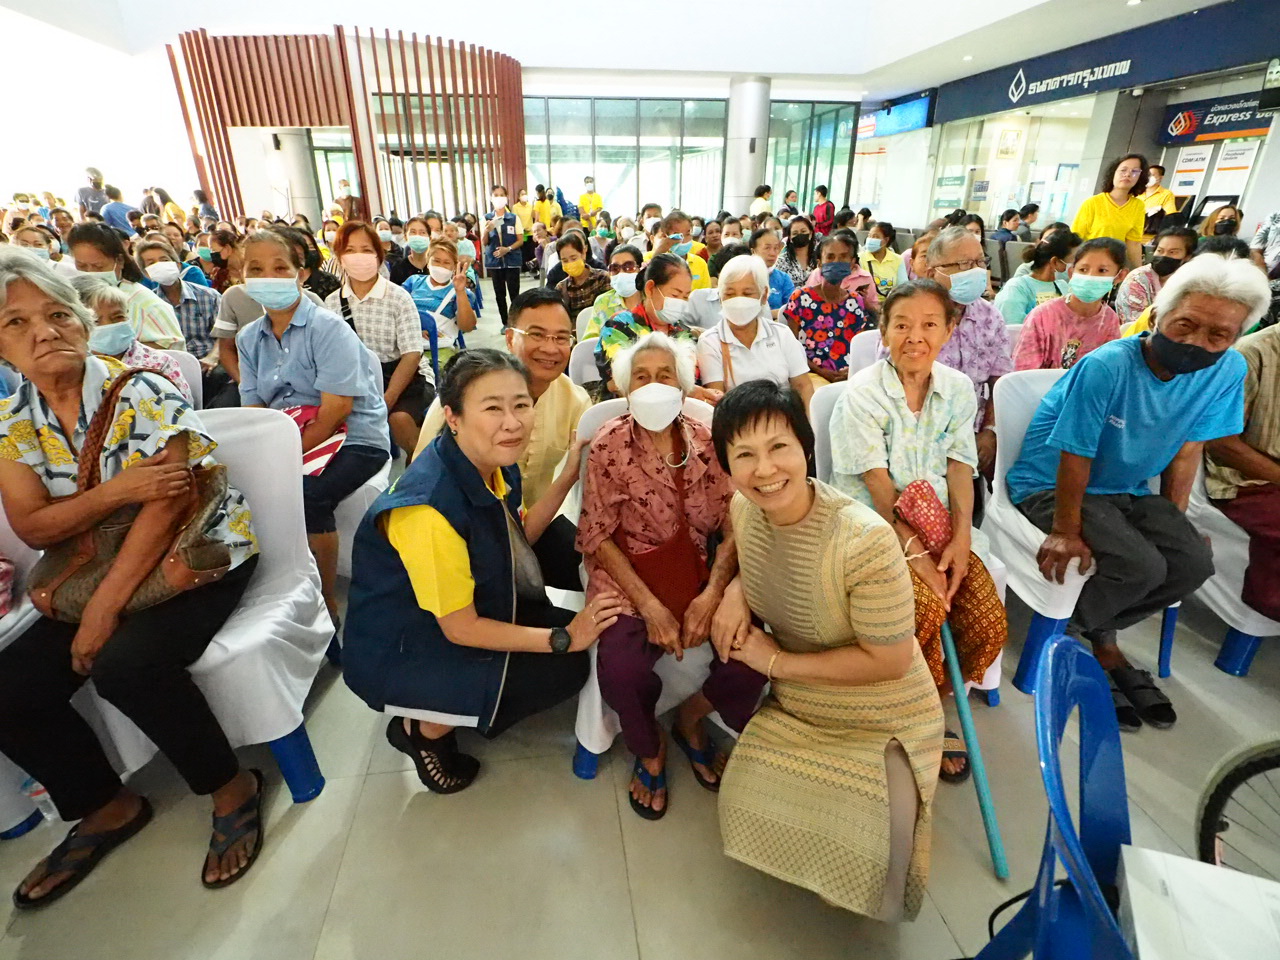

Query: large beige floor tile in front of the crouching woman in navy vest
316;758;637;960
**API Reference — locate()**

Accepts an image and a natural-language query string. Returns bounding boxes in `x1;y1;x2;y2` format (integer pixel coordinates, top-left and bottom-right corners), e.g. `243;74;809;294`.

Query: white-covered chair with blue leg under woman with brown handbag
0;408;333;812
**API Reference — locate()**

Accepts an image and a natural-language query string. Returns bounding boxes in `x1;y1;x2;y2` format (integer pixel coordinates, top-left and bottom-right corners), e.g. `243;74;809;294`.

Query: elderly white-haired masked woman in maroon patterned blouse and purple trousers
577;332;768;820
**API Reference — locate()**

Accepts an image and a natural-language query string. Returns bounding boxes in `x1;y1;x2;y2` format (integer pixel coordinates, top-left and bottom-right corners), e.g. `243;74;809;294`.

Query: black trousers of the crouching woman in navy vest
484;602;591;740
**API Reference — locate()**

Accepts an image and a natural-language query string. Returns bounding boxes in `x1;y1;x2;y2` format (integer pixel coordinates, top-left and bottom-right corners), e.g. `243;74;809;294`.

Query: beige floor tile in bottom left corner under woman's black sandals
0;780;361;960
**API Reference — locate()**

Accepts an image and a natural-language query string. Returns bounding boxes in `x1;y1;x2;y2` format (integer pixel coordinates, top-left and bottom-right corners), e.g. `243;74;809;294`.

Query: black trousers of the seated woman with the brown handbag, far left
0;557;257;820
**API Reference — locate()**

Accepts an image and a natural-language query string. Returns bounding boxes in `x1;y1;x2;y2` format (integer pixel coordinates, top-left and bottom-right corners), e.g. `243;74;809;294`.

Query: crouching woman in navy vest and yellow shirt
342;349;622;794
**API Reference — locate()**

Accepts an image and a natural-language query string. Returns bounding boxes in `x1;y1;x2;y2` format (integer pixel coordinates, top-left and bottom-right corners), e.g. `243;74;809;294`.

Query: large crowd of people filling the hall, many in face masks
0;172;1280;920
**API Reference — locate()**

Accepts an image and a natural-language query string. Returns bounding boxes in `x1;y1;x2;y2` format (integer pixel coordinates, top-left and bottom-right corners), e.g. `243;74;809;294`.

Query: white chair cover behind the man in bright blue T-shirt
975;370;1093;620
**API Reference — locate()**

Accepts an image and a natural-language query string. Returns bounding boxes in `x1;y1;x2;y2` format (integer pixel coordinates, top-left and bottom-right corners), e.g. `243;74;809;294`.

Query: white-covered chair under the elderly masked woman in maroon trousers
573;398;736;780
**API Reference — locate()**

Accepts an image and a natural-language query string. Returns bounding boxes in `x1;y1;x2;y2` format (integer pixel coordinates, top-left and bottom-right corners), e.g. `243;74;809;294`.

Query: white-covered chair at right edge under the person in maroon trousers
1187;470;1280;677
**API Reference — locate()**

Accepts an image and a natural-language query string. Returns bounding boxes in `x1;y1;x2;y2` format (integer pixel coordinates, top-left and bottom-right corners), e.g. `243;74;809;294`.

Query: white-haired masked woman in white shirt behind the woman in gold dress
698;255;813;408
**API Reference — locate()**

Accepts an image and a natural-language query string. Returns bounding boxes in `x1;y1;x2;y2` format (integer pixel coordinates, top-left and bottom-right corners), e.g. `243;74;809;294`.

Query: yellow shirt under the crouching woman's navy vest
384;470;507;617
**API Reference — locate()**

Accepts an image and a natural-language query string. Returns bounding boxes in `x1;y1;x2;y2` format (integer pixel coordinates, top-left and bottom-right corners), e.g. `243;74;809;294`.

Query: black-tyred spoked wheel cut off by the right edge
1196;742;1280;881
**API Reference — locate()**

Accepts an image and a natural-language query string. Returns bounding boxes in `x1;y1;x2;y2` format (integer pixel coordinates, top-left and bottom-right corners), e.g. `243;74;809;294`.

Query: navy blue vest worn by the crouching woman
342;430;521;732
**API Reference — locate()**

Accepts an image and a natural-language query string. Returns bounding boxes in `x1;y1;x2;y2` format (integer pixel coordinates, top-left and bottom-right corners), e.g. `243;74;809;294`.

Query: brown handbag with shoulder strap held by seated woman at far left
27;369;230;623
